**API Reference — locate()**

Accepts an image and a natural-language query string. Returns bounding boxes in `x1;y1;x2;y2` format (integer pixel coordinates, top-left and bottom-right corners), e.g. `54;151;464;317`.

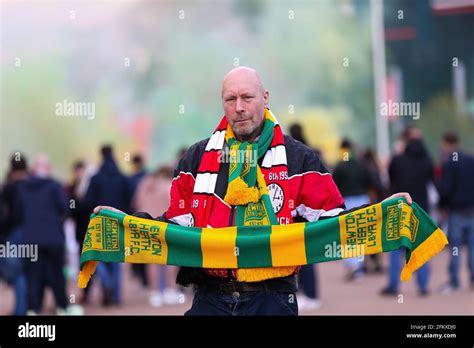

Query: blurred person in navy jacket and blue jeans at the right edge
438;132;474;293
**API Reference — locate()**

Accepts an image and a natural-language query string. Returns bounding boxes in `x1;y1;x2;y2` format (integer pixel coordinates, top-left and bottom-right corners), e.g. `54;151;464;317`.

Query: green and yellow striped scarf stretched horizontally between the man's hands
78;198;448;288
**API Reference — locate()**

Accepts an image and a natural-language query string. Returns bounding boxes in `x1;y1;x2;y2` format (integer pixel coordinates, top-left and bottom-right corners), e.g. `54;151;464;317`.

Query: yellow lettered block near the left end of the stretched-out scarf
123;215;168;265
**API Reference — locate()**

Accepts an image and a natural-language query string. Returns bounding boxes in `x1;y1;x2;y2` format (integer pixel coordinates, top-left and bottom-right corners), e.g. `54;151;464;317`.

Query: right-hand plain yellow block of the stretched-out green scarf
270;223;307;267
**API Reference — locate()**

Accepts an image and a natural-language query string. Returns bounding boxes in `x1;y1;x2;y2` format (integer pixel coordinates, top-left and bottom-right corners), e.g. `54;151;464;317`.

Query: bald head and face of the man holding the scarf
222;71;269;140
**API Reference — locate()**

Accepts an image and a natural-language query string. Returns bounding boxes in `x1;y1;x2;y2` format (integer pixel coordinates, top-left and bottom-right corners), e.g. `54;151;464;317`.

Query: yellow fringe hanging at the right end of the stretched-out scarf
400;228;448;282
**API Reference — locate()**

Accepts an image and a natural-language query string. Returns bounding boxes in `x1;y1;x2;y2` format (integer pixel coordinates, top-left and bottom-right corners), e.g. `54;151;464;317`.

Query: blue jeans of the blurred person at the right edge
448;211;474;288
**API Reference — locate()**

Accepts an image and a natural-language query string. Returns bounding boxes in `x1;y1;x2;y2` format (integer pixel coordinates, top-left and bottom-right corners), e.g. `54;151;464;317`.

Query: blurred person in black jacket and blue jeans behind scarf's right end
381;132;434;296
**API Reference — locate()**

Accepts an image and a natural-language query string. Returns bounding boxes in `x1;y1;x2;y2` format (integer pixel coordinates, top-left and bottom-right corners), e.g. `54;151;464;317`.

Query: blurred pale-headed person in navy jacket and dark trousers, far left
16;155;68;314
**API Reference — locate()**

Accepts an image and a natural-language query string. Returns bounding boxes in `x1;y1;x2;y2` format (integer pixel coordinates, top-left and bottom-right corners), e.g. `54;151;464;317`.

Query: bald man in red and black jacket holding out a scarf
95;67;411;315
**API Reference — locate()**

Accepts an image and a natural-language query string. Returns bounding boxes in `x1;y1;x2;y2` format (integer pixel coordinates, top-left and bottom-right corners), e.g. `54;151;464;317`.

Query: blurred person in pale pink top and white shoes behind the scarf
132;166;182;307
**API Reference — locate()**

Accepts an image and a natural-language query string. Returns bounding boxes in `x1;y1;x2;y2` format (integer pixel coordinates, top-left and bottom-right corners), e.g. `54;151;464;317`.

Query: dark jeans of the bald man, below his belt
184;289;298;316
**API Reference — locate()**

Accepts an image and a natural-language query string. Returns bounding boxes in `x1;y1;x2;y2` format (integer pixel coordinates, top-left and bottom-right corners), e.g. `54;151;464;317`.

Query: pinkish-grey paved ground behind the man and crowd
0;248;474;315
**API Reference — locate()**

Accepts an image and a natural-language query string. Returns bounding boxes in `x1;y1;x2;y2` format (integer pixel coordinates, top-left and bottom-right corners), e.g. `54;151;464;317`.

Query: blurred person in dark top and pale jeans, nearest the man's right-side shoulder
333;139;372;281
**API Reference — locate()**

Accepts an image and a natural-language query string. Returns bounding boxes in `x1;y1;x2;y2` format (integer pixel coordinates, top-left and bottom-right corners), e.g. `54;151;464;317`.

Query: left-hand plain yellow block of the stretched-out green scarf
201;227;239;268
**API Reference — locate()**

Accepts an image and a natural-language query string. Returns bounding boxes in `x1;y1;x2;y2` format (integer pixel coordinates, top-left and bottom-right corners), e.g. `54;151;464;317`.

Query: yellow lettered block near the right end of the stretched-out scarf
339;203;382;258
